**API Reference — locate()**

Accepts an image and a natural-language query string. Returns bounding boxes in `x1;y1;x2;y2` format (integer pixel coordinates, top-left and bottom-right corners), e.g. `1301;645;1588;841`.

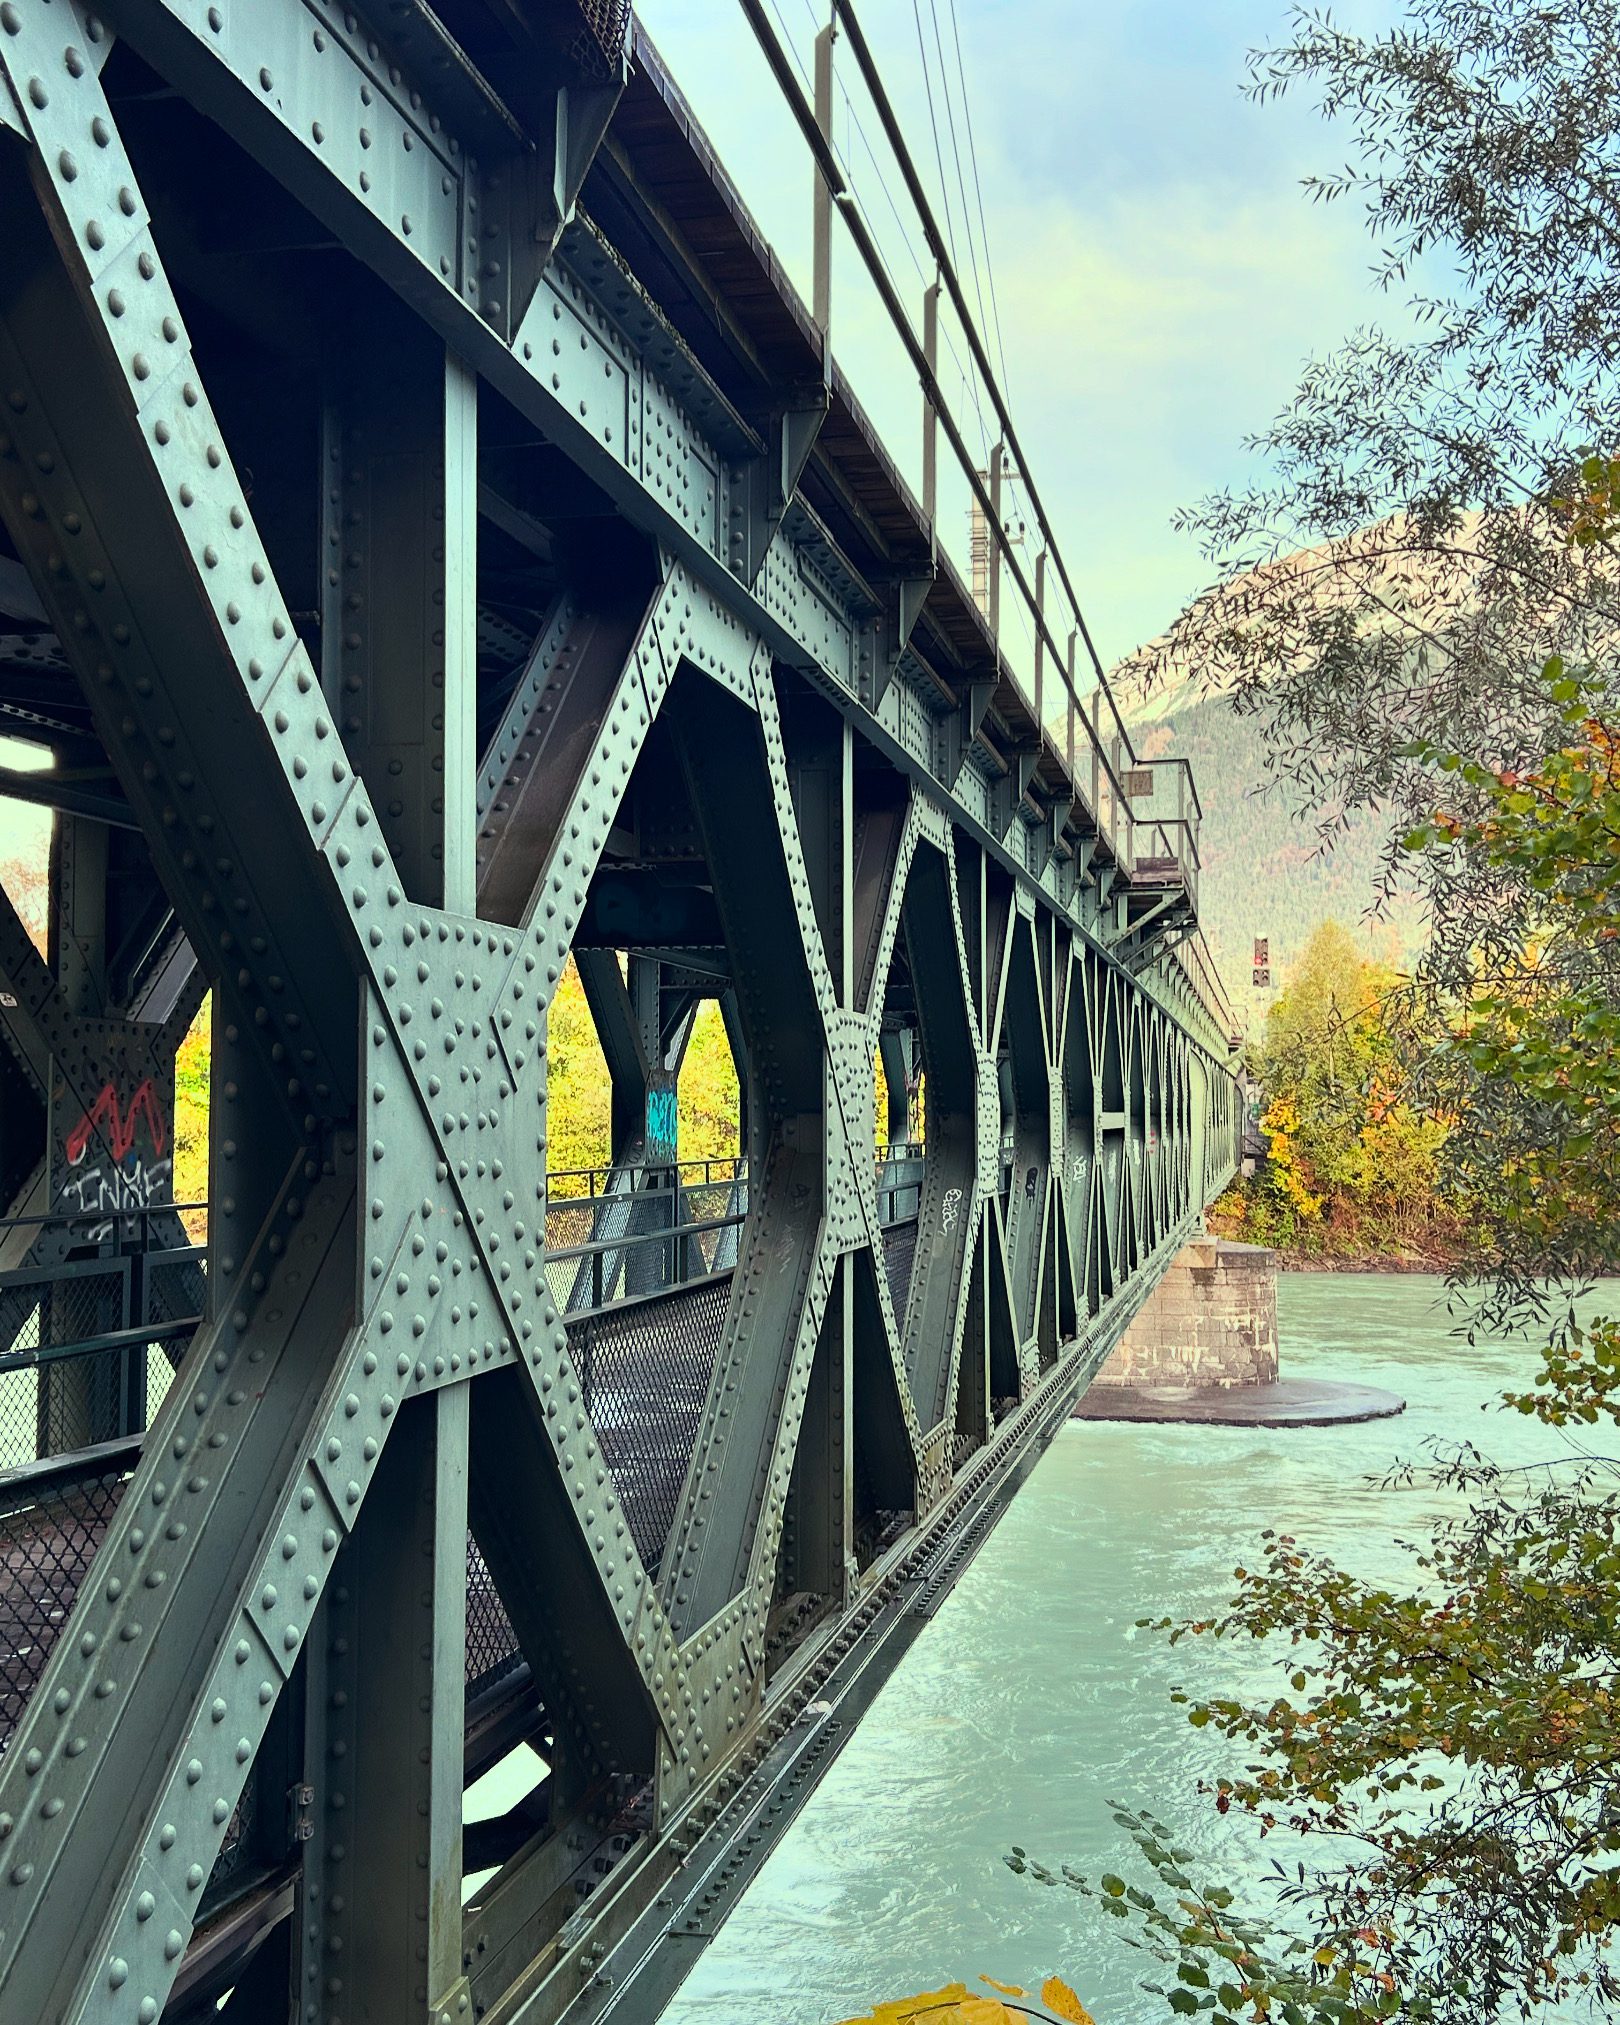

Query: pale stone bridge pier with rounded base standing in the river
1075;1235;1405;1428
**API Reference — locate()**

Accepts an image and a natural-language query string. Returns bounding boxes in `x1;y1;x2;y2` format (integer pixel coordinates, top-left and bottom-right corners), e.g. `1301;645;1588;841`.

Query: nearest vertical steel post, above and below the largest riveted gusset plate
298;319;478;2025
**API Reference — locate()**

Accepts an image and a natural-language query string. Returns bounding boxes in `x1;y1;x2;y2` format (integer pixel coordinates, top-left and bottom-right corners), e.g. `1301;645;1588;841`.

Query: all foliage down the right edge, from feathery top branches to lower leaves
1010;0;1620;2025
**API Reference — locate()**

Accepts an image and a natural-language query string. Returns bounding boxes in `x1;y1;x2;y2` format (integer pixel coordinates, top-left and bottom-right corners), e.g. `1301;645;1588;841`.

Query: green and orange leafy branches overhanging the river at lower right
1013;664;1620;2025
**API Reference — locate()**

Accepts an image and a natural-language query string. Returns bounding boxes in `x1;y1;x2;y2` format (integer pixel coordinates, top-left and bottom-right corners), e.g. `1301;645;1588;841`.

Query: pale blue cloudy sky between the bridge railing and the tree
638;0;1395;662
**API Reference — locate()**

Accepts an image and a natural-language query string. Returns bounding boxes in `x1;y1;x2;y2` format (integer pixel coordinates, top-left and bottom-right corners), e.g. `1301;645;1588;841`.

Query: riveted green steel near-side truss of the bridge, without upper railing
0;0;1239;2025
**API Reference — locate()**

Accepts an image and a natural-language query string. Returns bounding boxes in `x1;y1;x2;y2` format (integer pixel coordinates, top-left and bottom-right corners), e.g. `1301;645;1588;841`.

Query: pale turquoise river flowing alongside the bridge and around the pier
664;1274;1620;2025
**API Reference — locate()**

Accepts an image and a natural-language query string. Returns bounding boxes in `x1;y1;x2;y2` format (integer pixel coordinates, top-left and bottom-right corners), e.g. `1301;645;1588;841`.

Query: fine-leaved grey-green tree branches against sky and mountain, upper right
1140;0;1620;1093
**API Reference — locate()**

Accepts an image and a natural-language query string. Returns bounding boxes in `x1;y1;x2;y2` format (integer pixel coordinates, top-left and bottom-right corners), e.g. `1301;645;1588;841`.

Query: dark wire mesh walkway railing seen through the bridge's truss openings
0;1142;925;1773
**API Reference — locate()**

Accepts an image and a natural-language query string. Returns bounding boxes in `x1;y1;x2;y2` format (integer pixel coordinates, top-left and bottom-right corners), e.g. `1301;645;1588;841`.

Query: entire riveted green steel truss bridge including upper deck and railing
0;0;1239;2025
